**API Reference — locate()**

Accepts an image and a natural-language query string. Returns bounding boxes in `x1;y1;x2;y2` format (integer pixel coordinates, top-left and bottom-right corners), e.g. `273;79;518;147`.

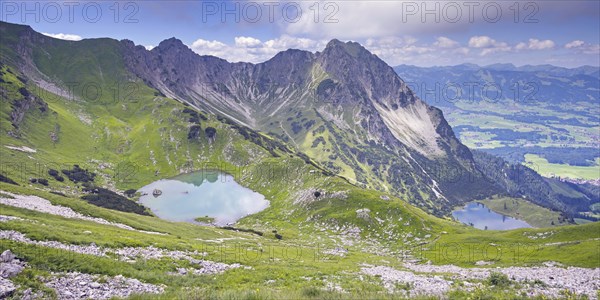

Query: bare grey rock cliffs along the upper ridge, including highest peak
122;38;469;159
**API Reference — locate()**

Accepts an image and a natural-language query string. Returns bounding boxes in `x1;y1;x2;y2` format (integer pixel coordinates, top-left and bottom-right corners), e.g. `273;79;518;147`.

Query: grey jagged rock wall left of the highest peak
122;38;314;127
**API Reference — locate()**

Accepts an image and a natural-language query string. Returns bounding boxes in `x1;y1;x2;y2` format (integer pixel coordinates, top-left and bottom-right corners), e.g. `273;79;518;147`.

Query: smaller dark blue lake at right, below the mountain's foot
452;202;532;230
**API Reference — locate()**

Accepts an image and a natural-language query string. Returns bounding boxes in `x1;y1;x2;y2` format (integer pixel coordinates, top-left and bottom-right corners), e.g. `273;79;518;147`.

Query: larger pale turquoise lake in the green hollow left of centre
139;171;269;226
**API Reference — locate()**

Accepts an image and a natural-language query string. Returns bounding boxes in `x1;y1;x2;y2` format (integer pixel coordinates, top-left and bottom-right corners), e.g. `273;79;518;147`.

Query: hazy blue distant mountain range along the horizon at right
394;64;600;107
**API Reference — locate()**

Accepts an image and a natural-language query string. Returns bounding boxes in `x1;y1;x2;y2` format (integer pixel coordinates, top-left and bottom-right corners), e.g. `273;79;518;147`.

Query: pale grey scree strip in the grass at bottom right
361;262;600;299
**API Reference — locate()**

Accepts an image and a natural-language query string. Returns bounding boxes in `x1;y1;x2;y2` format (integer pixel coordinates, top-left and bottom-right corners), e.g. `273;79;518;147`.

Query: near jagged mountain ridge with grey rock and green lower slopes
2;24;495;214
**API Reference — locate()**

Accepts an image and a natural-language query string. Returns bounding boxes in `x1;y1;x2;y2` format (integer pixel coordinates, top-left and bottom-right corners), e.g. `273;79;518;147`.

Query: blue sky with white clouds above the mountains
0;0;600;67
